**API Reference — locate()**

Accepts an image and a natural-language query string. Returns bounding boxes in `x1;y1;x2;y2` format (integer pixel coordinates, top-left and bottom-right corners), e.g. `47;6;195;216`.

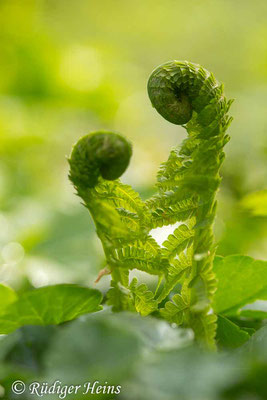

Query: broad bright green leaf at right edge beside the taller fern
213;255;267;315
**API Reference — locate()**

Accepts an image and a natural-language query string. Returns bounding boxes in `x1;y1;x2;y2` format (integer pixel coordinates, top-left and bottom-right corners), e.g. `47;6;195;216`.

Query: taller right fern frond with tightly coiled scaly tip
148;61;231;347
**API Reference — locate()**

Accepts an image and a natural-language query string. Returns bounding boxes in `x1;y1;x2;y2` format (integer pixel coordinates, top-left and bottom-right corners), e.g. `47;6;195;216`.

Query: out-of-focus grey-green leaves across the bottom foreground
0;311;267;400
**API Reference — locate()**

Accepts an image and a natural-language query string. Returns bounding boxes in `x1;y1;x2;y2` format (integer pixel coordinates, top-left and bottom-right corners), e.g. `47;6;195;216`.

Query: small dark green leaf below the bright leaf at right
216;315;250;349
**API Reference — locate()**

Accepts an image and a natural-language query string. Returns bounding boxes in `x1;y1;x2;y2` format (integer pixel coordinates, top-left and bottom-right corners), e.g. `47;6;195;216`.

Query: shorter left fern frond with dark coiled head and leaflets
69;131;160;287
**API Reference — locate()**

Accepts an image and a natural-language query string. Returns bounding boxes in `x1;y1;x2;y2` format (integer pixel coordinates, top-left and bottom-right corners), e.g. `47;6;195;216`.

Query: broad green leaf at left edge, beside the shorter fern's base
0;284;102;334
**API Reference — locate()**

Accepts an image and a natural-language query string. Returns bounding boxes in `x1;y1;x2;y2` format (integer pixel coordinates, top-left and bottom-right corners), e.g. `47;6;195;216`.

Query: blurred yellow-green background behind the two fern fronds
0;0;267;290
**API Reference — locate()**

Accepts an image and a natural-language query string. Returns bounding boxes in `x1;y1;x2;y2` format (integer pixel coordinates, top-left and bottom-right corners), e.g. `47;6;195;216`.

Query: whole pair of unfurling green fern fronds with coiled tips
69;61;232;348
